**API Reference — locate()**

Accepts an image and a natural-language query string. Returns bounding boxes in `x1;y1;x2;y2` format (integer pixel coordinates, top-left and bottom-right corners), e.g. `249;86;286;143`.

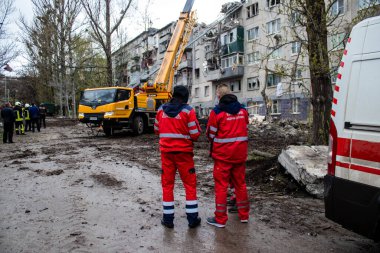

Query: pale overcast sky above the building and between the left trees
5;0;231;75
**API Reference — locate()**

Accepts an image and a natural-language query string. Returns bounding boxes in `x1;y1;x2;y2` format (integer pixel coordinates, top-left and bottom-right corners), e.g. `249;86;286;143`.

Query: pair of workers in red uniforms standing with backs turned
154;84;249;228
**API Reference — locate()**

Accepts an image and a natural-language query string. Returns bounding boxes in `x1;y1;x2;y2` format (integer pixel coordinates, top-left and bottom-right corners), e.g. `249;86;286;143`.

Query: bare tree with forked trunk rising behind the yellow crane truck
81;0;132;85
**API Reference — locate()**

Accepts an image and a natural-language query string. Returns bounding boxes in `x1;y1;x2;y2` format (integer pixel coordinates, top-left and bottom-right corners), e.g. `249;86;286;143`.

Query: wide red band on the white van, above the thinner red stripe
351;140;380;163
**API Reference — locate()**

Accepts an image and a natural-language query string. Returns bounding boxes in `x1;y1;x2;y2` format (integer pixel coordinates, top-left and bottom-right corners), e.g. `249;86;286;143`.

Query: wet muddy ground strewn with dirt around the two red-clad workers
0;118;380;252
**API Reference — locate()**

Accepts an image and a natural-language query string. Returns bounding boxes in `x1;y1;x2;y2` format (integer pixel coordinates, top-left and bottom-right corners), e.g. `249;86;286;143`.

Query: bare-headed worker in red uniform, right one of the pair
206;84;249;228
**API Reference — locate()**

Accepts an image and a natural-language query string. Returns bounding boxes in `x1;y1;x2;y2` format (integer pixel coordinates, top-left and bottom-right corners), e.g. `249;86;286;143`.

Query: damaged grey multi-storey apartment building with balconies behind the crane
113;0;372;120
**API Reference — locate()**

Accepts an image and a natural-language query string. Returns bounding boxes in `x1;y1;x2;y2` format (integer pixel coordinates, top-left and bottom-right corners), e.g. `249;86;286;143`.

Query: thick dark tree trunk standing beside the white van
306;0;332;145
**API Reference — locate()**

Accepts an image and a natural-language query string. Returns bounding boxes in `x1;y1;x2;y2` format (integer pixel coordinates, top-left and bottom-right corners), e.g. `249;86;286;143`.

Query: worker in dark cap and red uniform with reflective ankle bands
154;85;201;228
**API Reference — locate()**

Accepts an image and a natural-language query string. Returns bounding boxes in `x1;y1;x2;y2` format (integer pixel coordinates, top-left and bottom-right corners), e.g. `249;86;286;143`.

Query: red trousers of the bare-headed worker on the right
214;160;249;224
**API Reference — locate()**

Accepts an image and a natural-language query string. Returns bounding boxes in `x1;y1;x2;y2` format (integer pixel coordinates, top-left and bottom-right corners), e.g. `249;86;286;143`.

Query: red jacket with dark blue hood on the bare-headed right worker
206;94;248;163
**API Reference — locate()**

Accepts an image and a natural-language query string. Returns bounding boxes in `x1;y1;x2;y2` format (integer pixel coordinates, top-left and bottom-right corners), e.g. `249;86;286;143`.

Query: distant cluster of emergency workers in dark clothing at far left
1;102;46;143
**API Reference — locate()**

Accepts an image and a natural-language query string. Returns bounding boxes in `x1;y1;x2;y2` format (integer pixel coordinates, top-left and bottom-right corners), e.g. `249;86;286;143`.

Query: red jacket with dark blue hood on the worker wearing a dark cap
154;99;201;152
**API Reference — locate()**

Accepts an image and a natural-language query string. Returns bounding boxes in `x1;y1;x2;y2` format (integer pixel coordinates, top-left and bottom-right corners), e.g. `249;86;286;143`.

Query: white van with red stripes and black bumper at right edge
325;16;380;240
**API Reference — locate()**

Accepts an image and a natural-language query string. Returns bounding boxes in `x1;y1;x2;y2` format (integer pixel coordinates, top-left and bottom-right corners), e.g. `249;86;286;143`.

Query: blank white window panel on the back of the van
345;58;380;126
